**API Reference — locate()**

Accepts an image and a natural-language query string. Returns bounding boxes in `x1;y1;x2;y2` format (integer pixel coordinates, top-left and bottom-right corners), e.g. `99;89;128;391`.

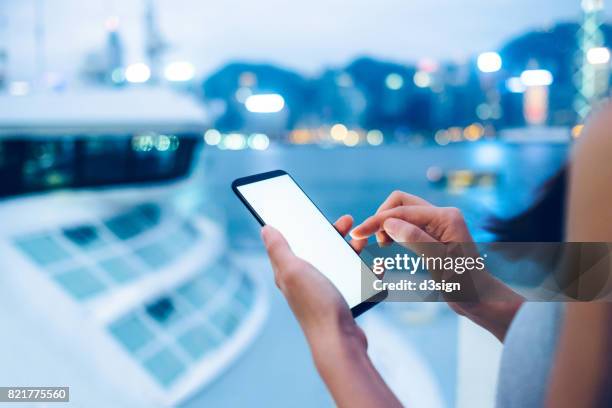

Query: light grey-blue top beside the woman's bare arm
496;302;564;408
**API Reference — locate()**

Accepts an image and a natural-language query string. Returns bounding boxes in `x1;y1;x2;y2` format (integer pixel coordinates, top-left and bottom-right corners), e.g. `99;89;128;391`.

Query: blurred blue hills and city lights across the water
202;21;612;142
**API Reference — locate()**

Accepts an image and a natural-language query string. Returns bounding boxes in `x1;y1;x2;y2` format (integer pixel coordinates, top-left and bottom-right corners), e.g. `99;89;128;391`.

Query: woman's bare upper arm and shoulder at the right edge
547;107;612;408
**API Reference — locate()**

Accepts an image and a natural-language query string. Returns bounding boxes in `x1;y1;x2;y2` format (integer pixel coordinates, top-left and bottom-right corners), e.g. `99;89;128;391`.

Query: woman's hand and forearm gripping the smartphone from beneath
261;216;401;407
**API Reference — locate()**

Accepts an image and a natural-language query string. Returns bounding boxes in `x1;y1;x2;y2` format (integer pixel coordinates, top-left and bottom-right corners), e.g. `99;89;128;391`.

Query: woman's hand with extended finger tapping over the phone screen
351;191;524;341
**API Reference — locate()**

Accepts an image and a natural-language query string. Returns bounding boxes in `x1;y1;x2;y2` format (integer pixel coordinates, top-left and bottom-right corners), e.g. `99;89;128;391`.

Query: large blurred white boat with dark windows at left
0;88;267;407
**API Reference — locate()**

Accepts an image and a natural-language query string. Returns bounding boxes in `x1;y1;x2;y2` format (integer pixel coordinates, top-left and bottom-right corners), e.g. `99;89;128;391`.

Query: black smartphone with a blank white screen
232;170;387;316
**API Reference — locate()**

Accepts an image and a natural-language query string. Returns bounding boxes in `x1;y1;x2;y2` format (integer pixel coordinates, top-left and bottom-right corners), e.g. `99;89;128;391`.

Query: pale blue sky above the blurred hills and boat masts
0;0;612;80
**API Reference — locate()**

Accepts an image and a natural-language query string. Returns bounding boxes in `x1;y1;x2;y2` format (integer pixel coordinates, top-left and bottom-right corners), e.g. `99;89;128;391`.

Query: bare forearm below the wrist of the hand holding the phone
308;326;401;408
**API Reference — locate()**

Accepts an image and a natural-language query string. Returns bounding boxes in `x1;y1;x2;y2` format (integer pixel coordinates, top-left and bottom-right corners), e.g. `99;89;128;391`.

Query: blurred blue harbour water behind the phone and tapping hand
202;142;567;245
